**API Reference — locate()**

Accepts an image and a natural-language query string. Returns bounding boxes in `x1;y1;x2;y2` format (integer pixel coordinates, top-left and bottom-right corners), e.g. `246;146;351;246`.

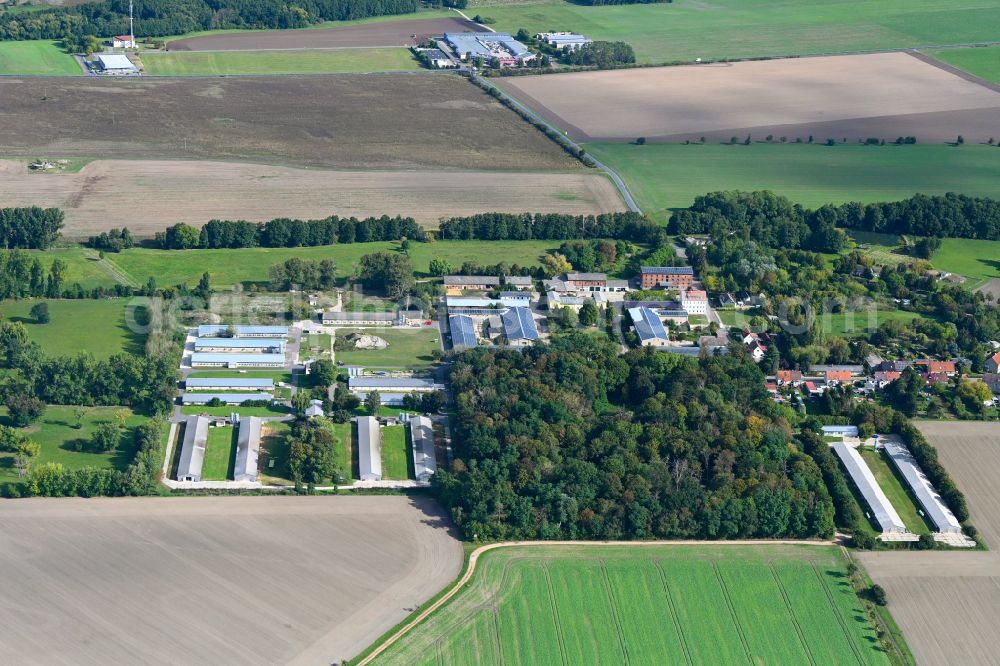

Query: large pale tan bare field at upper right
498;53;1000;143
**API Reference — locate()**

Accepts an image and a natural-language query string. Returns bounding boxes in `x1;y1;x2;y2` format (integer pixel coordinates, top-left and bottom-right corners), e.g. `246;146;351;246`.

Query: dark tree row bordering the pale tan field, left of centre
156;215;427;250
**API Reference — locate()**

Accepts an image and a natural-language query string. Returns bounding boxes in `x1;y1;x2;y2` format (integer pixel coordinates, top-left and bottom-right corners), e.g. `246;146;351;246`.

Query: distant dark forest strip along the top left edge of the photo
0;0;418;40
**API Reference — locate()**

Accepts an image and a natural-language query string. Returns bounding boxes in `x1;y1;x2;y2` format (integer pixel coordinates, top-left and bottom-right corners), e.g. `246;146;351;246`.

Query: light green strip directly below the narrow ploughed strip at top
142;48;421;76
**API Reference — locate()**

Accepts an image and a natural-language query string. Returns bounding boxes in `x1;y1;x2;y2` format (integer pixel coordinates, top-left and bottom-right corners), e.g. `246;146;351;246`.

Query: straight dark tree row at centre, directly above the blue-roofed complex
440;212;663;243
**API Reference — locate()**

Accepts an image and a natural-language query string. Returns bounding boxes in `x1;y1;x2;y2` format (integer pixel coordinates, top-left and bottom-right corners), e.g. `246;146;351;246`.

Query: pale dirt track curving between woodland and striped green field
356;539;839;666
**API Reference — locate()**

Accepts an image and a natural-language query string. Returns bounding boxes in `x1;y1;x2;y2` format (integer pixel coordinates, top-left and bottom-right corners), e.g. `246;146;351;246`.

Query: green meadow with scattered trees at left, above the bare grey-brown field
0;405;144;484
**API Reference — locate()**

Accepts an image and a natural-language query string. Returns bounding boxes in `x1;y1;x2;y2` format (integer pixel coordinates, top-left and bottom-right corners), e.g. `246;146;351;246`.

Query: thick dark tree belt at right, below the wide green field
668;191;1000;245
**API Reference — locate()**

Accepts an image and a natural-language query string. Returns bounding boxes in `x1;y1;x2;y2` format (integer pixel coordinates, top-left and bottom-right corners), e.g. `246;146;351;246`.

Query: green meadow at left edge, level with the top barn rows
0;298;145;358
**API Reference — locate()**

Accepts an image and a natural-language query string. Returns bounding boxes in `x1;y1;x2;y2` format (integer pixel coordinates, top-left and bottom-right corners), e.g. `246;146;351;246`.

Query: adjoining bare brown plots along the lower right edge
858;421;1000;666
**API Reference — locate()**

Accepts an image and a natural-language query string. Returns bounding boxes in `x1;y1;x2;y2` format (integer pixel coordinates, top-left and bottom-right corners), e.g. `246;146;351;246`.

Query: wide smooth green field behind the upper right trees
586;143;1000;217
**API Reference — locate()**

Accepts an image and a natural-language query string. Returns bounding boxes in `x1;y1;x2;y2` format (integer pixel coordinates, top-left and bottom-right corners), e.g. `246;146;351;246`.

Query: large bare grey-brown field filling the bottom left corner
0;497;463;664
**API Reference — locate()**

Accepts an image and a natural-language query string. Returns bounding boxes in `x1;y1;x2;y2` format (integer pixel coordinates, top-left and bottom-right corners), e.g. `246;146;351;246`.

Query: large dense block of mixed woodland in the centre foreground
434;334;834;540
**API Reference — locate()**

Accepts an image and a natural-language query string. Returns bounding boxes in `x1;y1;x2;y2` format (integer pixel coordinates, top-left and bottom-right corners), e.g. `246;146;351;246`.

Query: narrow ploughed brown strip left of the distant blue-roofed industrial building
167;16;481;51
